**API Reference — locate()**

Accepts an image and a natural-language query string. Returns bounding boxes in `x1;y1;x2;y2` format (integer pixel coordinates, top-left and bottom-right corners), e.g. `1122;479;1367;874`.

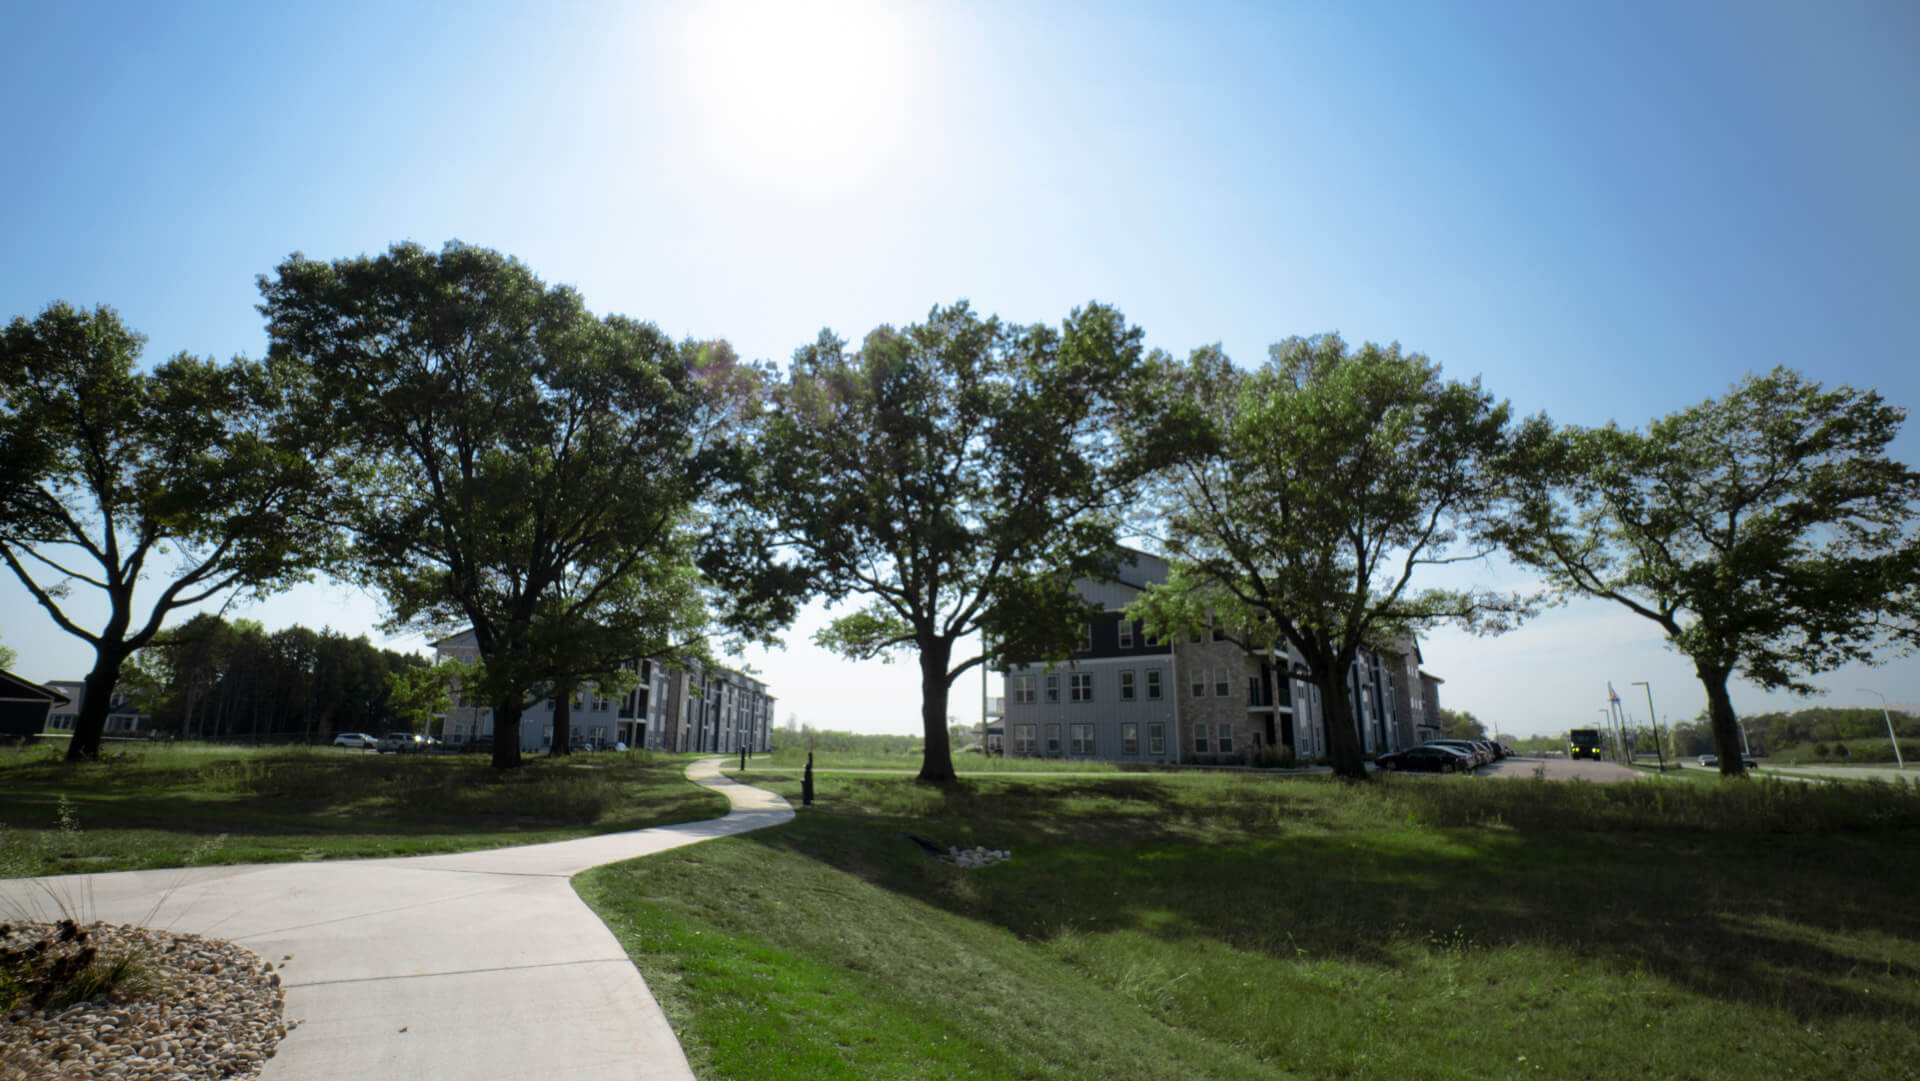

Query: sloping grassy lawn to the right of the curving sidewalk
576;772;1920;1081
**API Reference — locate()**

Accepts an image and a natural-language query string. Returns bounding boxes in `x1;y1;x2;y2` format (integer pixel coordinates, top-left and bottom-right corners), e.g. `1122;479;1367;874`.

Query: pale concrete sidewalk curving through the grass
0;758;793;1081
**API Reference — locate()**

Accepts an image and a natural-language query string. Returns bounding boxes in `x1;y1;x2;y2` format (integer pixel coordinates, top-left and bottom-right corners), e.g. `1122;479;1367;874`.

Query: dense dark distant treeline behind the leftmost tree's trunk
121;614;426;743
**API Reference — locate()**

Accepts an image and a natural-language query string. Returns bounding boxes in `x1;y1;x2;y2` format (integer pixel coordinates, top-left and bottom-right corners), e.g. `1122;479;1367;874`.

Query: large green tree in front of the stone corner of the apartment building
1129;334;1526;778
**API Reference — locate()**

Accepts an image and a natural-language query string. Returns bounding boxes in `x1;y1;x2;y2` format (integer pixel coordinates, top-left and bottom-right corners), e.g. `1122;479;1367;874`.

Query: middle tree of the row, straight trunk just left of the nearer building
729;303;1150;781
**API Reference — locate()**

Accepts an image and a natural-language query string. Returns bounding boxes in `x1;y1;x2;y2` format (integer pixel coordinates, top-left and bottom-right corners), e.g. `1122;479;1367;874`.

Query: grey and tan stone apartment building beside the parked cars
1002;549;1417;764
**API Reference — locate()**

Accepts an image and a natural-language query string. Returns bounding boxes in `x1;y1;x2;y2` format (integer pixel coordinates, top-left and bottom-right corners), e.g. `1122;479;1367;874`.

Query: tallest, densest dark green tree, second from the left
259;242;751;768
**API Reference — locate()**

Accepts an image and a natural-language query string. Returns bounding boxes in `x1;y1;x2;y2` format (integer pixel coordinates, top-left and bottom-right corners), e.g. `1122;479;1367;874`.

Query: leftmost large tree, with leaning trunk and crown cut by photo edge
0;303;330;758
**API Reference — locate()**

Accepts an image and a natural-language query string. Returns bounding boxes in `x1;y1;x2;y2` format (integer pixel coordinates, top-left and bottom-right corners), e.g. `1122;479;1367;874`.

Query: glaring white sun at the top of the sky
659;0;925;186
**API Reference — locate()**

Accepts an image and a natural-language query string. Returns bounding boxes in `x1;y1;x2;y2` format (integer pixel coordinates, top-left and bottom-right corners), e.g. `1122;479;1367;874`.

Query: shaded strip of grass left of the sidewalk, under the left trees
0;745;728;877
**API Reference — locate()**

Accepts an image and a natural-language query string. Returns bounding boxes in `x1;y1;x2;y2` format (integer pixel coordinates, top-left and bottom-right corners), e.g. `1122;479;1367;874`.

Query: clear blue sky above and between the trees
0;0;1920;733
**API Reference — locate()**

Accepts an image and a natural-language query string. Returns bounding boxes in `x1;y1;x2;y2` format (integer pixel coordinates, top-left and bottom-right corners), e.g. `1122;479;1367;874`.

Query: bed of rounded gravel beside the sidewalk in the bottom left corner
0;922;292;1081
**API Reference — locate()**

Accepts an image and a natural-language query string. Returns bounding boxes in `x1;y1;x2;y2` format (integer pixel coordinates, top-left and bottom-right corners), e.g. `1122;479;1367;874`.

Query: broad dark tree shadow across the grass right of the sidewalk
733;778;1920;1025
